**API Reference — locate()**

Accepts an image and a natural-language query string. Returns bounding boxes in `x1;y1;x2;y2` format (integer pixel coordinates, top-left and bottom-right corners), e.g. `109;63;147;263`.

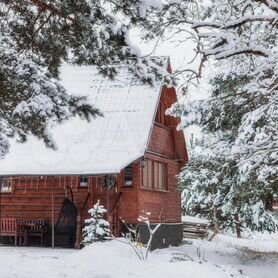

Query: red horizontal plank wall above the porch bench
1;177;88;222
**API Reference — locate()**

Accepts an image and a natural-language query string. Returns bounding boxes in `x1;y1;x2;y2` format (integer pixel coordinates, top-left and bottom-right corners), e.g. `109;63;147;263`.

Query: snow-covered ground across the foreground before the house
0;234;278;278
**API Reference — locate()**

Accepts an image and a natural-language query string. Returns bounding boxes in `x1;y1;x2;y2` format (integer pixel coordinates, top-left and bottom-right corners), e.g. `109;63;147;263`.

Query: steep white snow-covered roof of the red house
0;61;167;175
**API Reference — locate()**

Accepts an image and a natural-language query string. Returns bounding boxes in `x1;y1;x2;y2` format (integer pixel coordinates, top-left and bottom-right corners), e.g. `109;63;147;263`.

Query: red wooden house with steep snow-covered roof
0;58;187;247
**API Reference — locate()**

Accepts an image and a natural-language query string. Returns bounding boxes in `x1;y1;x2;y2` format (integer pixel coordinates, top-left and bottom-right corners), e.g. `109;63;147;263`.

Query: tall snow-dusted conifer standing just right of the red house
176;75;278;235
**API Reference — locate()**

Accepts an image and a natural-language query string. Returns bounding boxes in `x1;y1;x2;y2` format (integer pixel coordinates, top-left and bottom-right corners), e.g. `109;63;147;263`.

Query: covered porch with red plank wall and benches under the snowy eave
0;176;121;248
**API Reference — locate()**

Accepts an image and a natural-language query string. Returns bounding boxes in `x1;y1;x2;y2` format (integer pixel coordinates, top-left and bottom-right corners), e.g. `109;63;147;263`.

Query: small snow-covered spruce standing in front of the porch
82;200;111;245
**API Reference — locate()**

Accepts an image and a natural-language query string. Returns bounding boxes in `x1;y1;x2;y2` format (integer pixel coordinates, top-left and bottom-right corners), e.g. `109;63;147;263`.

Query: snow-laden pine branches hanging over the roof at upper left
0;0;169;158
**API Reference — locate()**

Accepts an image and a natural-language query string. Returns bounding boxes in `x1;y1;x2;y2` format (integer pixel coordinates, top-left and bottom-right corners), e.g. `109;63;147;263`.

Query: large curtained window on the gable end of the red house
143;160;167;190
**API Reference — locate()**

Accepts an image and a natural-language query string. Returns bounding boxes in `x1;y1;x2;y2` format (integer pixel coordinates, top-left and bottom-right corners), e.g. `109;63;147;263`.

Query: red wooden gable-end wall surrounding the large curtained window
136;87;188;223
